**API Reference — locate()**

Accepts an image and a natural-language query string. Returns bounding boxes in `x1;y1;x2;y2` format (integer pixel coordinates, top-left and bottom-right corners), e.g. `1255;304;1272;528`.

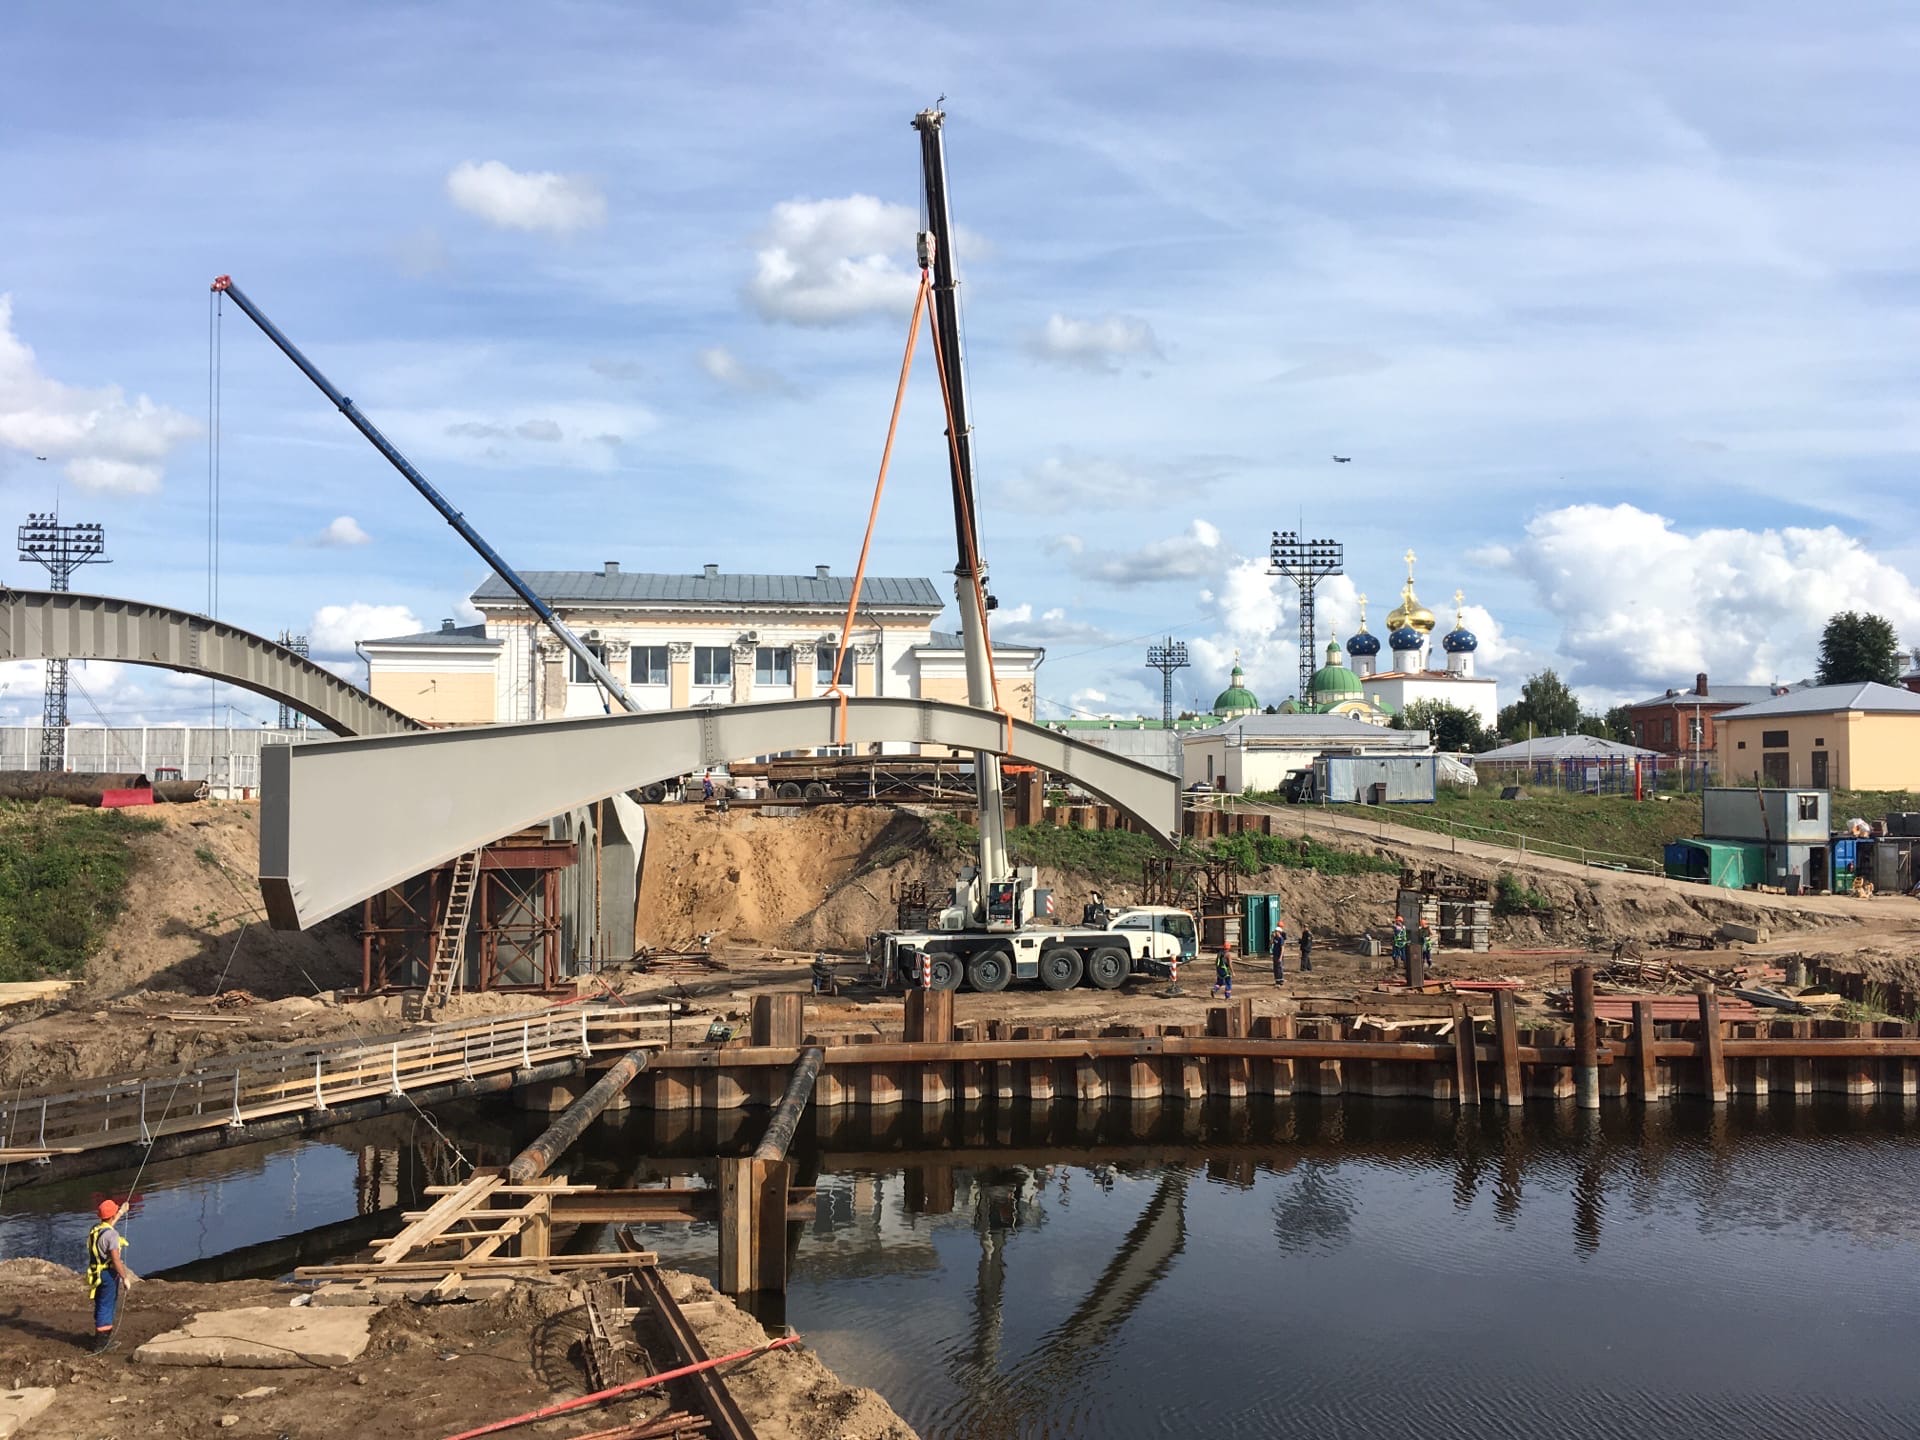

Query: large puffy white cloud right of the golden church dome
1482;505;1920;689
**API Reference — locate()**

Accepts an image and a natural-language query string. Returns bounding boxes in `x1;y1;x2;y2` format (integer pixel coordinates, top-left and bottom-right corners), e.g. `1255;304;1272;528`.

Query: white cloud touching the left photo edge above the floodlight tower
0;294;200;495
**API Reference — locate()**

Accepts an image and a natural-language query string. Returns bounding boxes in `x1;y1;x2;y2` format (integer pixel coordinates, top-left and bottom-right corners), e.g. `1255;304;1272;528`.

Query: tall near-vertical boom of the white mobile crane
914;109;1012;916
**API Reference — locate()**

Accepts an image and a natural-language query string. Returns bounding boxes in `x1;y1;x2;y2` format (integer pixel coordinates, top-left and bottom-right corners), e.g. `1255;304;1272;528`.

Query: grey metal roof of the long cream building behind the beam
472;570;945;611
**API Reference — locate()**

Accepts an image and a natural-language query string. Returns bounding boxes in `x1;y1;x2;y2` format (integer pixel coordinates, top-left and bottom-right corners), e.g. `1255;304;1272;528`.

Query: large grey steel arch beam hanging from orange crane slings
259;699;1181;929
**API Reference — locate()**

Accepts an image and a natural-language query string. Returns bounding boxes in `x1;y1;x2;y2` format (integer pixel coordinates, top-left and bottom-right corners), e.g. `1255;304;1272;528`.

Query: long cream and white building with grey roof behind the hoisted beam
359;561;1044;744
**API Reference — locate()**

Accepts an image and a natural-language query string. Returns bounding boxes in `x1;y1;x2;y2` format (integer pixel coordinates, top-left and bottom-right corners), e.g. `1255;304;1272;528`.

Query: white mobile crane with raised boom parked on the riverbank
868;109;1198;991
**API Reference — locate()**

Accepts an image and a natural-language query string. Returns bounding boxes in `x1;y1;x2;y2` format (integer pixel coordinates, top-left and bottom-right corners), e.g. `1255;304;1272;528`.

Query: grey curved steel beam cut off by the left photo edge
0;589;420;735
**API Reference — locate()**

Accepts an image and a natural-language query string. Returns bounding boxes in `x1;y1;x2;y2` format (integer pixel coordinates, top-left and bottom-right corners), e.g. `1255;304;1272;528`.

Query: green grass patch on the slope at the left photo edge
0;801;159;981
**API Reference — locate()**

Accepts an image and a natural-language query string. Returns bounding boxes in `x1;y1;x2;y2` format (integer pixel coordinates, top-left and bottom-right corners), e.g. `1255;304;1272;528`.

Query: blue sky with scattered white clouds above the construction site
0;0;1920;724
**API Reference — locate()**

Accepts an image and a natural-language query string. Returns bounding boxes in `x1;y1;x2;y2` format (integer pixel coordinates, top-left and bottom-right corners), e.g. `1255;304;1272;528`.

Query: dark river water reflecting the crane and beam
0;1100;1920;1440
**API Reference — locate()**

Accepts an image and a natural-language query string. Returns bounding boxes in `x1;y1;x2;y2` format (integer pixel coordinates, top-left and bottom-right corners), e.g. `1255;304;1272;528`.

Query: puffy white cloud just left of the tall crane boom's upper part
747;196;920;324
